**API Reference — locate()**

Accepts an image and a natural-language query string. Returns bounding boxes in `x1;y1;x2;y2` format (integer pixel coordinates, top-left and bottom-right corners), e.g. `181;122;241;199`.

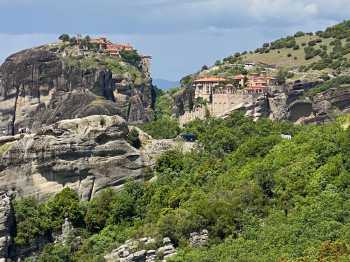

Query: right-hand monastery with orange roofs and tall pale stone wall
180;71;278;125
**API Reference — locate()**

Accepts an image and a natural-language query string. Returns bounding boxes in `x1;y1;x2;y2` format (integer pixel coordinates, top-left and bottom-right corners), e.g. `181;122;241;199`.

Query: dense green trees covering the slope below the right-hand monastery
14;113;350;262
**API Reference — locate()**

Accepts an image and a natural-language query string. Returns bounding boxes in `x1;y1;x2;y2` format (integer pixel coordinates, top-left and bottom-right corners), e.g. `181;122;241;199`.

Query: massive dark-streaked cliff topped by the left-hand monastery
0;45;155;135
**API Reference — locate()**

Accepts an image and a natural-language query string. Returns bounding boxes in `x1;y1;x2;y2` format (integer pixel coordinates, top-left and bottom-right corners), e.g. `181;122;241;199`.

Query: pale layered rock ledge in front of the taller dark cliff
0;116;148;200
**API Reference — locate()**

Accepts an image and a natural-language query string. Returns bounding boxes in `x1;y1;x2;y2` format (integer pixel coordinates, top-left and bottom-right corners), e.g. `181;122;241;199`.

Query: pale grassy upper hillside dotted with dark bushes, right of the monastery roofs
234;21;350;70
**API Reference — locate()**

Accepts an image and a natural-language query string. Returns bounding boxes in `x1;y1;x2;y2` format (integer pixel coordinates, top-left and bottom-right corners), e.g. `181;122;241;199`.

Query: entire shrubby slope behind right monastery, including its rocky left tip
178;21;350;86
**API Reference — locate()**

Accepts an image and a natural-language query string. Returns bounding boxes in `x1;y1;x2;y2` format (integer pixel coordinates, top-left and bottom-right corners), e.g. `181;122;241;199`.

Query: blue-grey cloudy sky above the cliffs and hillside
0;0;350;81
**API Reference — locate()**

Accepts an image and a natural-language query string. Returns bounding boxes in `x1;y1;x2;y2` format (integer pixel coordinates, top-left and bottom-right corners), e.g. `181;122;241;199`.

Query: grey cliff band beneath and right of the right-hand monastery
174;81;350;123
